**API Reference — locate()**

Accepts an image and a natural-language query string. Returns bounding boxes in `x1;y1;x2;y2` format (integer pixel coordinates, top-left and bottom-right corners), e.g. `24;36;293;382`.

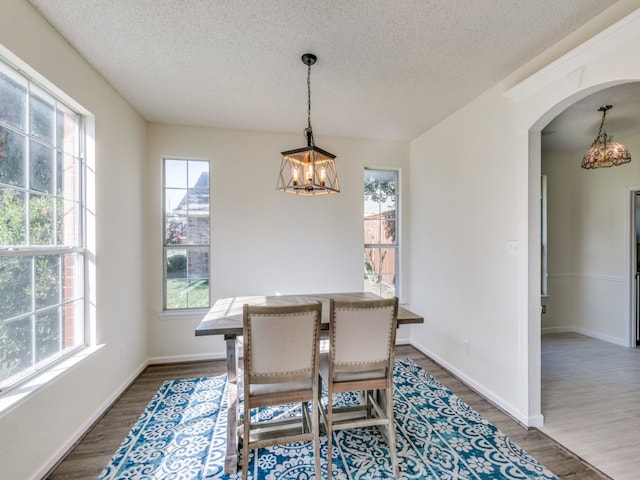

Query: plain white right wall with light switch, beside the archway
411;82;526;418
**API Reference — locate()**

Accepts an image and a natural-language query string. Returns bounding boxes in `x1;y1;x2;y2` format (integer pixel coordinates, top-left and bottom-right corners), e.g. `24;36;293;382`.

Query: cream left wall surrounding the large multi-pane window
0;0;148;480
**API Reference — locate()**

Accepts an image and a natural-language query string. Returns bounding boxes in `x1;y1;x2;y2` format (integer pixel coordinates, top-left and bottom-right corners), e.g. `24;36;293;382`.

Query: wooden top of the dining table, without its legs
196;292;424;337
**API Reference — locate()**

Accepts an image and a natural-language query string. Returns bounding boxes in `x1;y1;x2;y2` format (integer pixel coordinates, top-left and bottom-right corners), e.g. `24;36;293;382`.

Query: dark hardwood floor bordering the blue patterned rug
46;346;608;480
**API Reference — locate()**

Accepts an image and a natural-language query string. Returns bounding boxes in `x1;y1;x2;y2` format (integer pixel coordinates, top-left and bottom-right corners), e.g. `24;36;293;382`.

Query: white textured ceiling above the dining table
29;0;615;143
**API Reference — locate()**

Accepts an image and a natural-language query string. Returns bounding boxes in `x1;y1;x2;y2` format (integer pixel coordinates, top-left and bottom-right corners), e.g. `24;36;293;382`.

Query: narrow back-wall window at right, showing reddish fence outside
364;169;398;298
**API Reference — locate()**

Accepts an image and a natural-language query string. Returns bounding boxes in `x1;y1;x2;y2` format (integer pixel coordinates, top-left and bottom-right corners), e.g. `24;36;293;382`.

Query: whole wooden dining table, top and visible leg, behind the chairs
195;292;424;475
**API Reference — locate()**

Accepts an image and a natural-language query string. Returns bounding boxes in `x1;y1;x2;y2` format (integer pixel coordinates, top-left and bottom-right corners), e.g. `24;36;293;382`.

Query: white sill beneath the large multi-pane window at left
0;345;103;417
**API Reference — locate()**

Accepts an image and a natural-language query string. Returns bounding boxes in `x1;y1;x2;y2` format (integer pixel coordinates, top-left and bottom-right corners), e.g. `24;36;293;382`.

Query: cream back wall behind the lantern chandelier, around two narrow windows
146;124;410;361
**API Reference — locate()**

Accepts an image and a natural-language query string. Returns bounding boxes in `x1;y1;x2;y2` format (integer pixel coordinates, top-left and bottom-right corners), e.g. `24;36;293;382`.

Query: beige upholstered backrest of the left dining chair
243;302;322;383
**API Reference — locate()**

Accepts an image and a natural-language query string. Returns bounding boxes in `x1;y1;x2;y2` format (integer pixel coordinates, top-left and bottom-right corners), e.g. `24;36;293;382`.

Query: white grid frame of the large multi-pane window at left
0;57;90;397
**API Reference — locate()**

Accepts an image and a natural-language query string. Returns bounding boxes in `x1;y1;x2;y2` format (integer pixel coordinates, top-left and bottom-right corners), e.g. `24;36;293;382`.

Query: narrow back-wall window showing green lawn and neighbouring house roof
164;158;210;310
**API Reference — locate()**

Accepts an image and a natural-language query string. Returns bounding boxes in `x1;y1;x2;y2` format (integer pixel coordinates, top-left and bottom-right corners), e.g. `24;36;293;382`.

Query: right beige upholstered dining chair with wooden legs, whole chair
320;298;400;478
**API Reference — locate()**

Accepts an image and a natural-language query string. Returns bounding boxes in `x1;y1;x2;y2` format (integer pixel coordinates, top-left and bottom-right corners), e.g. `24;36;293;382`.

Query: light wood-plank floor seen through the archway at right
542;333;640;480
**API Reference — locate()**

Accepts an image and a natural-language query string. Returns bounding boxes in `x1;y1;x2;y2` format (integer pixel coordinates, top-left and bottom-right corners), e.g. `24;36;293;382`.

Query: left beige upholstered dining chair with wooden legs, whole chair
239;302;322;480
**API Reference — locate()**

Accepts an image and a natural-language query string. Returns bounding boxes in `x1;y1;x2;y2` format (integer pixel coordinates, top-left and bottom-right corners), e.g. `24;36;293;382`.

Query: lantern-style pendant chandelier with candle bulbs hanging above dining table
276;53;340;196
